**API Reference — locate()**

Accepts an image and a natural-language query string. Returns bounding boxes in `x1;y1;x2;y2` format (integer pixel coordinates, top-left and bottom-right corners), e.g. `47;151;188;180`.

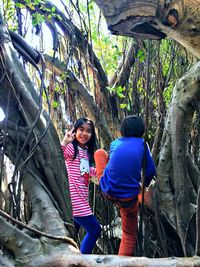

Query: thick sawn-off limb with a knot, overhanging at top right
95;0;200;58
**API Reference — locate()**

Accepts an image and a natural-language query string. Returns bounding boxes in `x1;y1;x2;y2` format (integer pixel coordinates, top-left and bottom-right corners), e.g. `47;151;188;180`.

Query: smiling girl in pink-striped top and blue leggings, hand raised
61;118;101;254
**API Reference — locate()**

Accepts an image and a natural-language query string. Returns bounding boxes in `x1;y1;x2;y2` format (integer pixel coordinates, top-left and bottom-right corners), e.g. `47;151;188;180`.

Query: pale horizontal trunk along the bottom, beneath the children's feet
21;254;200;267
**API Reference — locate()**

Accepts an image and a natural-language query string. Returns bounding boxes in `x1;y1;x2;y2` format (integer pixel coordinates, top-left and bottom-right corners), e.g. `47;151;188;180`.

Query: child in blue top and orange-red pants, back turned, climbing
94;115;156;256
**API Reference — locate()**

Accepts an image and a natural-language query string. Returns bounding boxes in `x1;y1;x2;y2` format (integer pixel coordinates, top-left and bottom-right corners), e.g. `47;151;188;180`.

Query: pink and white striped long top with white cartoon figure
61;143;96;217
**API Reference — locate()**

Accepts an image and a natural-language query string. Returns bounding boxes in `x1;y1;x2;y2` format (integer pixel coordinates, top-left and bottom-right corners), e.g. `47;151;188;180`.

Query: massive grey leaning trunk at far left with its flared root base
0;14;78;266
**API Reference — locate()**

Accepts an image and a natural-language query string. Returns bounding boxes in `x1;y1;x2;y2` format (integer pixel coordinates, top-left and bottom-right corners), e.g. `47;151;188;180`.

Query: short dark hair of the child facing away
120;115;145;137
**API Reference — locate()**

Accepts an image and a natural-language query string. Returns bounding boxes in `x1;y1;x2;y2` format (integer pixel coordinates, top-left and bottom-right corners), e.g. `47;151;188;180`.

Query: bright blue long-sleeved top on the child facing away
100;137;156;198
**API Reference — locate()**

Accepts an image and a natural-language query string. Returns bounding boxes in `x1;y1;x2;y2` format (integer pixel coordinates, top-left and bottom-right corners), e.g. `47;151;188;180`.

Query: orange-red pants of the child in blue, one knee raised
94;149;138;256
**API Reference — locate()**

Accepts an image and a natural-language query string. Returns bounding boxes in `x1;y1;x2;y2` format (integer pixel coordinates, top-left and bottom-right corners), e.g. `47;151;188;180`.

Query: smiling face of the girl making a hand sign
76;123;92;148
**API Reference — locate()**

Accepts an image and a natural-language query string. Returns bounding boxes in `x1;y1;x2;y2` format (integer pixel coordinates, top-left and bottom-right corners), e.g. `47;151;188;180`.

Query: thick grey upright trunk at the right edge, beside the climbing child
157;63;200;255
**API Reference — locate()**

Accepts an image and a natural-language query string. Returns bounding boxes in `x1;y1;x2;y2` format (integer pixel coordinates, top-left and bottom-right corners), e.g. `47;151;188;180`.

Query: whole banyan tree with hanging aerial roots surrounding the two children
0;0;200;266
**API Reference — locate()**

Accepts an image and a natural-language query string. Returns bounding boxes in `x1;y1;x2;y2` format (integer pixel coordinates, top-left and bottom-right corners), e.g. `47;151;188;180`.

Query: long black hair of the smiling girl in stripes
72;118;97;165
